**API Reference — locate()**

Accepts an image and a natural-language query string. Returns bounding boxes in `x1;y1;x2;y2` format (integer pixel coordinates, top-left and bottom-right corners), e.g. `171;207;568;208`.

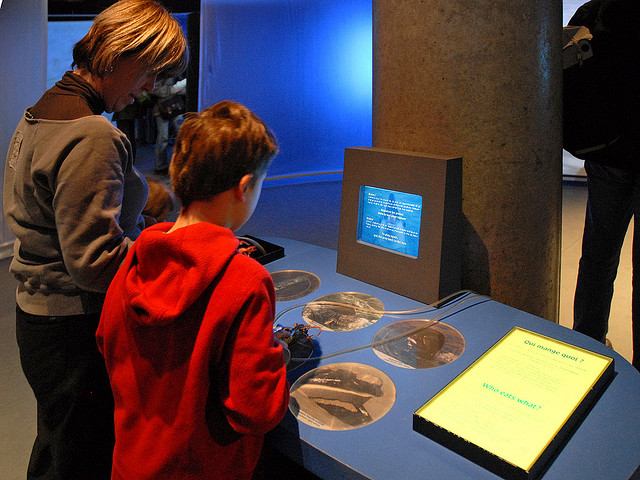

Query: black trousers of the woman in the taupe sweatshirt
16;308;114;480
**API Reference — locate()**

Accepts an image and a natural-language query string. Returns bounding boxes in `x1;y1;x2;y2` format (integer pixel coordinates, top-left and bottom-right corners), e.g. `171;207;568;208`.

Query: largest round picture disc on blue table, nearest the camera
289;363;396;430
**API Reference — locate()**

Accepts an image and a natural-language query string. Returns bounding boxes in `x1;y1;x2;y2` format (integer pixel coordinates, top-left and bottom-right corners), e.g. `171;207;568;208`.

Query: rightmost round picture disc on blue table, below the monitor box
373;319;465;368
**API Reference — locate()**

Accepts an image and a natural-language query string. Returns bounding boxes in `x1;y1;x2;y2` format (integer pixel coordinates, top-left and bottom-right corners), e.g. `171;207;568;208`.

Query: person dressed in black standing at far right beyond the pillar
569;0;640;369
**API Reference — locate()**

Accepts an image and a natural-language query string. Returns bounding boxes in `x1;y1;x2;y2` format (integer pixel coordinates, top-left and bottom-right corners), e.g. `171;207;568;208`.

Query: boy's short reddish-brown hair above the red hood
169;100;278;207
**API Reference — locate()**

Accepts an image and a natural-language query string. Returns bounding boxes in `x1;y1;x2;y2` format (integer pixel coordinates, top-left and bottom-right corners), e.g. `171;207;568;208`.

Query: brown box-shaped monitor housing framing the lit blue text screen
337;147;462;303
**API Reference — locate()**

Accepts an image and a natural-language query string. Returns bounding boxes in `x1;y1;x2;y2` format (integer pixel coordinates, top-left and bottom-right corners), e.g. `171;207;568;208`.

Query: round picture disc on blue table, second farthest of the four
302;292;384;331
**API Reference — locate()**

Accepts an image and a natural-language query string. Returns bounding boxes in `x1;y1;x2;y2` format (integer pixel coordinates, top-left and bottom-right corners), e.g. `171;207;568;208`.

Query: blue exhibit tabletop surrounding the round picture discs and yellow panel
267;238;640;480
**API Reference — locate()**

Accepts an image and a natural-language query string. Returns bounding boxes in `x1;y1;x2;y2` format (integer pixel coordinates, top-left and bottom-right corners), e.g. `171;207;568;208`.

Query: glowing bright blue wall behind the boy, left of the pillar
200;0;372;176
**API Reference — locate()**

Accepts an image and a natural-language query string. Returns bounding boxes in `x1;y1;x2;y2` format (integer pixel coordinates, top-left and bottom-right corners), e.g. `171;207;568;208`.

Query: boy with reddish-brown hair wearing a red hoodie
97;101;289;480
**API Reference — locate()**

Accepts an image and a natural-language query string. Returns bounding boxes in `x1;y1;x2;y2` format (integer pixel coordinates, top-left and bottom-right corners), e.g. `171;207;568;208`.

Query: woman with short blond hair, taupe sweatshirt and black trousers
3;0;187;480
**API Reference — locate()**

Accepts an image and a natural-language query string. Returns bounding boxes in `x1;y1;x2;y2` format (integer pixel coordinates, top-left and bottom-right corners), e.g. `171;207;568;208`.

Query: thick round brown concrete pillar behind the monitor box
373;0;562;321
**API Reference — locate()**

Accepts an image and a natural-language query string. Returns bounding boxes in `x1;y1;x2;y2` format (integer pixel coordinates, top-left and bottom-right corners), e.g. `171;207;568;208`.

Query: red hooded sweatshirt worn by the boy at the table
97;223;289;480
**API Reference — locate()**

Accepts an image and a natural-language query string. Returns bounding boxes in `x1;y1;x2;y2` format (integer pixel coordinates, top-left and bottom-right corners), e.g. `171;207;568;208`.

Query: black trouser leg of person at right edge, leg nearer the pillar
573;161;634;342
